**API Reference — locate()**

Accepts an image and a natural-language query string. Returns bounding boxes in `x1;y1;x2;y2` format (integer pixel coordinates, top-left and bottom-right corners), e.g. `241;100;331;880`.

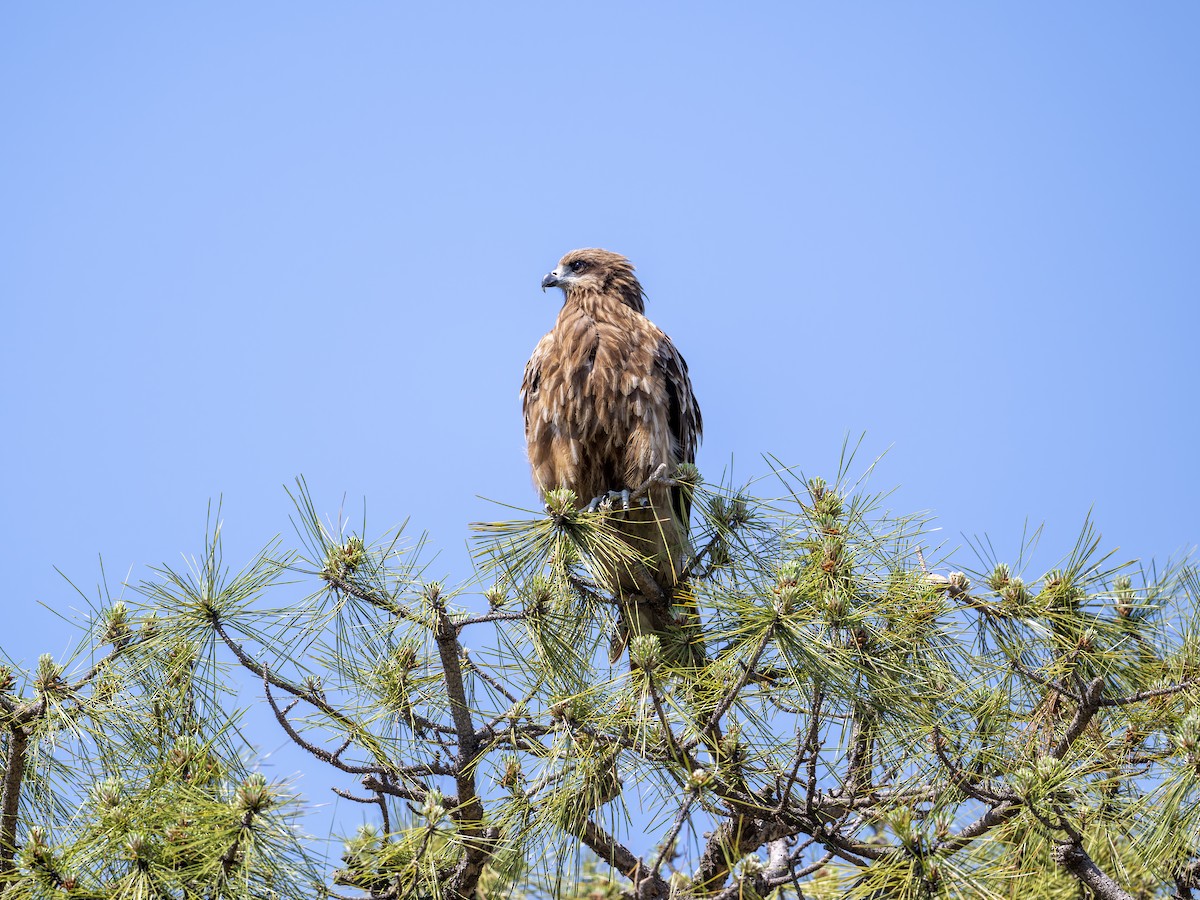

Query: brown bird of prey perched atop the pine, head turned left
521;248;702;661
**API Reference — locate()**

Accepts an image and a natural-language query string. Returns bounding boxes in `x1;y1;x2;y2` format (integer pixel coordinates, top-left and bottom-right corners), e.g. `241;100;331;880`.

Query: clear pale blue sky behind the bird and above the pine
0;2;1200;868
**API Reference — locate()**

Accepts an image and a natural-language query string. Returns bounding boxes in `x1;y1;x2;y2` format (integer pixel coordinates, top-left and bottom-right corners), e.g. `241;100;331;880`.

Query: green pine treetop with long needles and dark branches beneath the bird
0;460;1200;900
